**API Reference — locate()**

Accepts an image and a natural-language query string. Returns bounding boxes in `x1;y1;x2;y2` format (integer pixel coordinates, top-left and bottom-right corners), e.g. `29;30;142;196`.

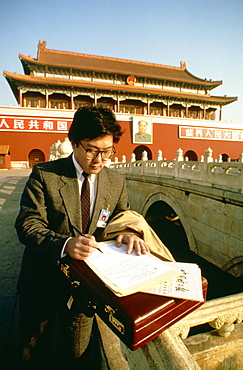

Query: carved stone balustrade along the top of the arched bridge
110;148;243;193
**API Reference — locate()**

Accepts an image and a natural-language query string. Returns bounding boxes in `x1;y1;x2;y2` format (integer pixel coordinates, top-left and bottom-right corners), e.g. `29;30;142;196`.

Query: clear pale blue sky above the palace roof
0;0;243;124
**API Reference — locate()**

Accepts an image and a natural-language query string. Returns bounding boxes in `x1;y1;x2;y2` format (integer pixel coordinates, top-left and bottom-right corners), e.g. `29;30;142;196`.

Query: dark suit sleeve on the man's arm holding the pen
15;165;70;261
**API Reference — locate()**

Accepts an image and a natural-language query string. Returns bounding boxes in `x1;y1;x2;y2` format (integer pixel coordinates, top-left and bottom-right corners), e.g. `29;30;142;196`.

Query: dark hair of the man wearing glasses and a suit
68;107;123;143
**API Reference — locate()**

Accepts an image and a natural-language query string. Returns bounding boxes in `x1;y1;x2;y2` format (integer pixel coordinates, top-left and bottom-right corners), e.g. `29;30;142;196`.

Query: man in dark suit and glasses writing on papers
15;107;148;370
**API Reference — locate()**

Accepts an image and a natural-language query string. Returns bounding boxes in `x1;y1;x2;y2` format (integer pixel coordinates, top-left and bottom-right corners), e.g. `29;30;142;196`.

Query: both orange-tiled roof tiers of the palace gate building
4;41;237;106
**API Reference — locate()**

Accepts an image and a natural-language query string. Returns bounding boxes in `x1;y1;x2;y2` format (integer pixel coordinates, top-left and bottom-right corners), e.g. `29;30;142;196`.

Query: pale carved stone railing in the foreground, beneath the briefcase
98;293;243;370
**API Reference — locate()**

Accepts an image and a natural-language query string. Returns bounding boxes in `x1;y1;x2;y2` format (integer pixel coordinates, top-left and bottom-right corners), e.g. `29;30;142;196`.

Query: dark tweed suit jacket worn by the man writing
15;156;128;295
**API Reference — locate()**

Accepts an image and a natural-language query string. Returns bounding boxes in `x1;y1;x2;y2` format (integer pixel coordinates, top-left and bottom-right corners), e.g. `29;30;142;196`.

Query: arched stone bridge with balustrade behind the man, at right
110;148;243;277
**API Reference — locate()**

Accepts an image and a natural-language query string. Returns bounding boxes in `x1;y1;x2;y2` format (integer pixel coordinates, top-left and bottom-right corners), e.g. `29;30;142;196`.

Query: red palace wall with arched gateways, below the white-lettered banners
0;114;243;161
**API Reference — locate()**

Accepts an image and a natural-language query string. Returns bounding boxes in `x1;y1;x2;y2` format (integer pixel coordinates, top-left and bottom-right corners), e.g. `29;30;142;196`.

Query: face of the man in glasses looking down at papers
73;135;113;174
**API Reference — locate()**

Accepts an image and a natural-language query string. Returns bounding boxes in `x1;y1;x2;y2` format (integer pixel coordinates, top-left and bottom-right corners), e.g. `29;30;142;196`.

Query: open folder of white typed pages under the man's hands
85;241;181;296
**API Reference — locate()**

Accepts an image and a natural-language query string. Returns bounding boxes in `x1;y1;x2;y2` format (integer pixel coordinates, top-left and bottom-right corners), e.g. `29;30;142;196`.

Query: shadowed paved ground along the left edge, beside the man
0;170;30;370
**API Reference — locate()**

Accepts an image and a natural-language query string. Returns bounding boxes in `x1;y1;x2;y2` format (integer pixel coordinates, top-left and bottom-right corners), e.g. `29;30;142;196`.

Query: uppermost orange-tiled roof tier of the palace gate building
19;41;222;90
